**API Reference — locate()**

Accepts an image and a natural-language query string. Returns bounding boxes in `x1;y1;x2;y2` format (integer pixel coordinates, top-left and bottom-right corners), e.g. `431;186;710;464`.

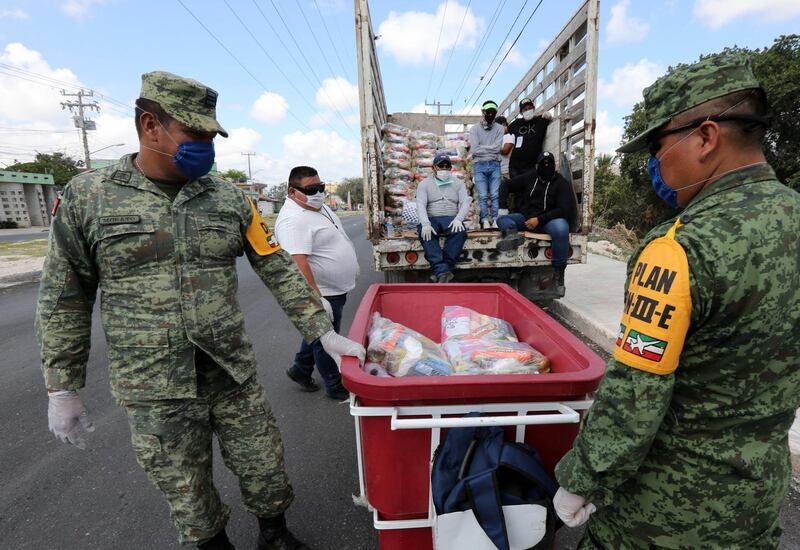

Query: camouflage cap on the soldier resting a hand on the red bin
139;71;228;137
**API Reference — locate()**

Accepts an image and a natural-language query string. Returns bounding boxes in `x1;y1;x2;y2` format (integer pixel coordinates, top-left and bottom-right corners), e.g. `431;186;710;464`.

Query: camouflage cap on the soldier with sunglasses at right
617;53;761;153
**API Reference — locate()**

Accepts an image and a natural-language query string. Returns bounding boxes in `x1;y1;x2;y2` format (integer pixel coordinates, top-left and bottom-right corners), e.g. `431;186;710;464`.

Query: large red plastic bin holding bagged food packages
342;283;605;550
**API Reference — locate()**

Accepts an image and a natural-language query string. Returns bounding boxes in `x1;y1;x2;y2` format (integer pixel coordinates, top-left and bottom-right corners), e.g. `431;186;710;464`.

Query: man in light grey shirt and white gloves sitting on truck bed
417;153;472;283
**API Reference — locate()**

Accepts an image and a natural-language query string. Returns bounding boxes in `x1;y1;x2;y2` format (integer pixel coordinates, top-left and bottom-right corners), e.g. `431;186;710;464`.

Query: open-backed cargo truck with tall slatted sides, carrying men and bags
355;0;599;299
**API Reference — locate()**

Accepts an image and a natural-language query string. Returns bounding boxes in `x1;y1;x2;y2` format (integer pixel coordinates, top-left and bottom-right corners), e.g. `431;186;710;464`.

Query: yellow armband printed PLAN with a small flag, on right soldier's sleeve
614;220;692;374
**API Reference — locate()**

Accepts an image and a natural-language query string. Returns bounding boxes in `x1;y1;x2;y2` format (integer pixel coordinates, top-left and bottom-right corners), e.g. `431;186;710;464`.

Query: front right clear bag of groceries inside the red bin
442;337;550;374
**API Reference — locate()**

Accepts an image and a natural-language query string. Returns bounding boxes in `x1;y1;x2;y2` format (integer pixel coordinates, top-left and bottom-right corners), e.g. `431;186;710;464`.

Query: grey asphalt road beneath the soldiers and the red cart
0;216;800;550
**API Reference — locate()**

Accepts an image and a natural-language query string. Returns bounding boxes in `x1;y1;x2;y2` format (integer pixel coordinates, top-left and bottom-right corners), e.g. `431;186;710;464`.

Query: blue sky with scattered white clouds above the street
0;0;800;187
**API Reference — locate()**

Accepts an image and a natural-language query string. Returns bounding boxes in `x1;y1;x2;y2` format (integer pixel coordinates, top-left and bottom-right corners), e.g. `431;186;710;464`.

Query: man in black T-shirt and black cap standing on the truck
502;97;553;178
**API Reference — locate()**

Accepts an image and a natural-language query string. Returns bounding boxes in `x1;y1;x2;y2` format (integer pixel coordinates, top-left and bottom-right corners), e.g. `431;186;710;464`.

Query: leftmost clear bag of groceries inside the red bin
367;313;453;376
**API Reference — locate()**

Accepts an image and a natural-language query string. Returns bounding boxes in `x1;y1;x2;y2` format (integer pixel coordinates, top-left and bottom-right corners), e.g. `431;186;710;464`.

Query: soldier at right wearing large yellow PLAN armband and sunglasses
554;54;800;550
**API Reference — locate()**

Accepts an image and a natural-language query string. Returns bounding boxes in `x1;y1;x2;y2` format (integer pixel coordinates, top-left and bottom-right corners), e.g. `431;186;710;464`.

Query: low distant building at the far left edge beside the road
0;170;57;227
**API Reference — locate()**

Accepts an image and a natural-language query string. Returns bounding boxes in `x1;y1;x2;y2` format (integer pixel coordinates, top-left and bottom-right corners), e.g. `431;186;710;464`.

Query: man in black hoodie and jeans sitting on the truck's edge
497;152;576;296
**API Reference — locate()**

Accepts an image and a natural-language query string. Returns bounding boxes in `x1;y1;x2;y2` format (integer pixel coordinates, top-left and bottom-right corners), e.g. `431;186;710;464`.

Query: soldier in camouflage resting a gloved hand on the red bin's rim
36;72;363;549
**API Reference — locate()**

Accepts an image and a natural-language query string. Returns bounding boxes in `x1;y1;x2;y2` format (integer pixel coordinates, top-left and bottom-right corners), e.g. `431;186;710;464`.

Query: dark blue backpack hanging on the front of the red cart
431;413;558;550
